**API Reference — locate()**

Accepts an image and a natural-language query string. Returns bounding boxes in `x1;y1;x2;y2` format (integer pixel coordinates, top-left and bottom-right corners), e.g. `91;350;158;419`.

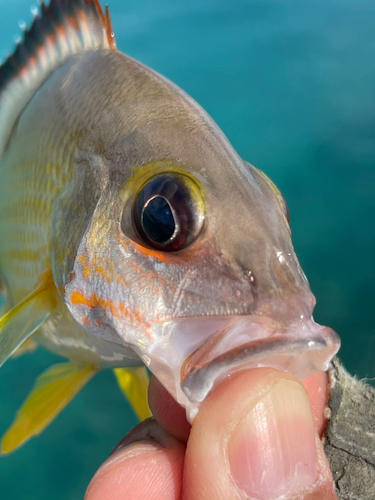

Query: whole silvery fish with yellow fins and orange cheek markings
0;0;340;454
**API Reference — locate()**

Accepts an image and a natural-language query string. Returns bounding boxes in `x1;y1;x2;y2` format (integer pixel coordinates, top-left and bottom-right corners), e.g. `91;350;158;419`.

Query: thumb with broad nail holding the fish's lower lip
183;368;336;500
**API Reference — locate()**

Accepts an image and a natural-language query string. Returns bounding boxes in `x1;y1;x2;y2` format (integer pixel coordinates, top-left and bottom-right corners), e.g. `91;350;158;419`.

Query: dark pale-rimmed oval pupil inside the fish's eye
142;196;176;243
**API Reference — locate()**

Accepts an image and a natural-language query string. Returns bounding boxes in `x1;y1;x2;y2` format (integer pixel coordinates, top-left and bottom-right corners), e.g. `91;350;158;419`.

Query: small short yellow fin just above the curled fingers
113;366;151;420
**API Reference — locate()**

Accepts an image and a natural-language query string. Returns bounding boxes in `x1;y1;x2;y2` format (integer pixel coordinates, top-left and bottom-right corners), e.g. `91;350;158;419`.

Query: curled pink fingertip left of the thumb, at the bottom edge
85;419;185;500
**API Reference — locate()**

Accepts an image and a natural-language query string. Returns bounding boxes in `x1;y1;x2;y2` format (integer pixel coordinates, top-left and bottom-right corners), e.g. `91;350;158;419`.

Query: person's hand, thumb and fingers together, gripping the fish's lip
85;368;336;500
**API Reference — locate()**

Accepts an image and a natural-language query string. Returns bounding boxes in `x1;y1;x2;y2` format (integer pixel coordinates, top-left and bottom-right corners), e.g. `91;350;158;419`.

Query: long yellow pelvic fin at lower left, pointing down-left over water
1;363;96;453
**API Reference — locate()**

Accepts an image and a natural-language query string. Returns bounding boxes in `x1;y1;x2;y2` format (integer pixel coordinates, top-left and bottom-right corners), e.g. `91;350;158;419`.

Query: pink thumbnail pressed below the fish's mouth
227;379;318;500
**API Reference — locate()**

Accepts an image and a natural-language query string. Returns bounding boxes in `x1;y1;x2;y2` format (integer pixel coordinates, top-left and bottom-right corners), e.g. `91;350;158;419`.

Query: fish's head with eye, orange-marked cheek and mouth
54;51;339;420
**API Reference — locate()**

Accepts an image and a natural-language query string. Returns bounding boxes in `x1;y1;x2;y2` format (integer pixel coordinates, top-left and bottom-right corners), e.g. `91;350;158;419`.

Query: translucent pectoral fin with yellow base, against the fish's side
0;269;56;366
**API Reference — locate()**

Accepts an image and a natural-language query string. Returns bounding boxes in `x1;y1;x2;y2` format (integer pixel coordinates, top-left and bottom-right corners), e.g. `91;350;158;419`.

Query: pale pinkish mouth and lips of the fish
141;316;340;422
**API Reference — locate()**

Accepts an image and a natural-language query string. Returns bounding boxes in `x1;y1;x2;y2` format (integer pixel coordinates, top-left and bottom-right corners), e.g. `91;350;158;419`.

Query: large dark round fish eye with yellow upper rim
133;172;204;252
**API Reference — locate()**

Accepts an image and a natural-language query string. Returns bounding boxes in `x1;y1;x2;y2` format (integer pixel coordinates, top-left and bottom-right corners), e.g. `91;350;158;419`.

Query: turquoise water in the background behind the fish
0;0;375;500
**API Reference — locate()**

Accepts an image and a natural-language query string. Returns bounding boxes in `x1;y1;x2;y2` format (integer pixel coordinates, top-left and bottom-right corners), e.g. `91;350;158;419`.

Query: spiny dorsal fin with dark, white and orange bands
0;0;116;158
